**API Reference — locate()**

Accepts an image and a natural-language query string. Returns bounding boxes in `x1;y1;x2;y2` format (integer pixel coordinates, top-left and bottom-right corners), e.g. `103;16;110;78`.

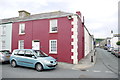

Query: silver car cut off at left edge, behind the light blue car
0;50;11;62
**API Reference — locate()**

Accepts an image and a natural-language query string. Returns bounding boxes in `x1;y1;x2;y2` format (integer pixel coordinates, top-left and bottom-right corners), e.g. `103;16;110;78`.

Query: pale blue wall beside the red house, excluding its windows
0;23;12;51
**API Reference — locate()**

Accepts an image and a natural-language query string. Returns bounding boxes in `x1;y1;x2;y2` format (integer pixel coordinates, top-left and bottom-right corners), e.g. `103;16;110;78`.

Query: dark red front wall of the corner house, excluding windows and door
12;17;73;63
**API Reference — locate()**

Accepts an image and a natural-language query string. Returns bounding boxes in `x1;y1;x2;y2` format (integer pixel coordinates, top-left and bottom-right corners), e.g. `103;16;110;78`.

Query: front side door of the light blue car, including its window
24;50;36;67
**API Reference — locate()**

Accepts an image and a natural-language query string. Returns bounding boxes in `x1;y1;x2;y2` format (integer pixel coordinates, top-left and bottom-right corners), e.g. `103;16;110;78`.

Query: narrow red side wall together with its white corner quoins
71;15;84;64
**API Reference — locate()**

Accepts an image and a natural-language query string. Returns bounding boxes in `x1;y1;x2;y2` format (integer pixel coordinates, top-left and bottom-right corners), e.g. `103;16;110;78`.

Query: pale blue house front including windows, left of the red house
0;20;12;51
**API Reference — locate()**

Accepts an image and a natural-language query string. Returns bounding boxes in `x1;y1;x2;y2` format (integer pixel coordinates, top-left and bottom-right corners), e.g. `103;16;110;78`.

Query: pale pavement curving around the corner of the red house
58;50;96;70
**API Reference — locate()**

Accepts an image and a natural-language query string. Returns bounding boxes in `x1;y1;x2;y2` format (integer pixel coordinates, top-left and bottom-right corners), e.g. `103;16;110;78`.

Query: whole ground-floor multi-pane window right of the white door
49;40;57;54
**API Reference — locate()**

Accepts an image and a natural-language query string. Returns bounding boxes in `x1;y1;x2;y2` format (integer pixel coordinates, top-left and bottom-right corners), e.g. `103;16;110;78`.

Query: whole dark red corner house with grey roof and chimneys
12;10;84;64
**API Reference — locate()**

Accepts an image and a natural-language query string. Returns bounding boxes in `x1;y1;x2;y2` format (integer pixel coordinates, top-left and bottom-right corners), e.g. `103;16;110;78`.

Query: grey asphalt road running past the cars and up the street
0;48;119;78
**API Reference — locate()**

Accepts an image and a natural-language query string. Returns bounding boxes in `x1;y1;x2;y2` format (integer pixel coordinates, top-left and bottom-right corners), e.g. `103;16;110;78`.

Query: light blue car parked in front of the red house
10;49;57;71
